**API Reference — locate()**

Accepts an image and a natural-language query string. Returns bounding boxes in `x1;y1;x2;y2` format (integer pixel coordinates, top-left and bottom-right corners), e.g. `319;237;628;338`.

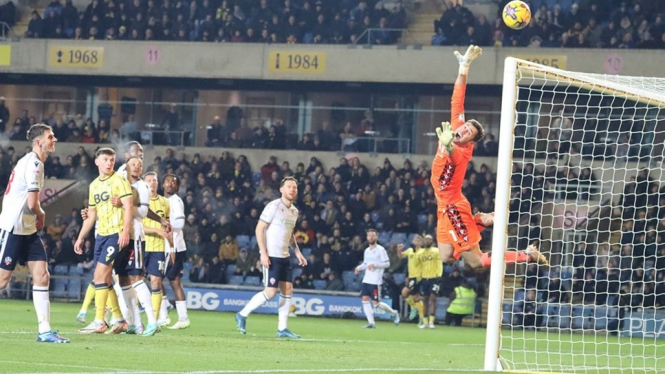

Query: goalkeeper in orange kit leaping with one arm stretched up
431;45;547;269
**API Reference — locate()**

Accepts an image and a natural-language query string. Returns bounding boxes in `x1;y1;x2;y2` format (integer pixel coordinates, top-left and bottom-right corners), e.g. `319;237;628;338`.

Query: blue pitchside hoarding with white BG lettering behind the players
185;287;392;319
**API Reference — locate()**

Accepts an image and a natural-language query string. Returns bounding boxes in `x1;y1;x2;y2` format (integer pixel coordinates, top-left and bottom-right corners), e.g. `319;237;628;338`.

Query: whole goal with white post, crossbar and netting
485;58;665;373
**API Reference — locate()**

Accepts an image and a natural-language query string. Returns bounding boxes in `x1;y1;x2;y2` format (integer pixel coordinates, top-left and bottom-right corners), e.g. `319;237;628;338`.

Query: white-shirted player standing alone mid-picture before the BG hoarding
235;177;307;339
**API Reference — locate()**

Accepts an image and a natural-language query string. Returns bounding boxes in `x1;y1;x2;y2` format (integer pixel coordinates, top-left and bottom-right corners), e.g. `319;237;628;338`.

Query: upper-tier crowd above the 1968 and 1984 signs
26;0;406;44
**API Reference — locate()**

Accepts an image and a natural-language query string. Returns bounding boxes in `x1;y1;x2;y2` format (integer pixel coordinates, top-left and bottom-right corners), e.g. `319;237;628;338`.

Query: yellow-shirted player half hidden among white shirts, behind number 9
143;172;171;325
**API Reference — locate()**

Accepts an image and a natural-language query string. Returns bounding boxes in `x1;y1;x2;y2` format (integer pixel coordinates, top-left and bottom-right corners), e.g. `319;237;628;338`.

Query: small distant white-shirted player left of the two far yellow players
355;229;399;329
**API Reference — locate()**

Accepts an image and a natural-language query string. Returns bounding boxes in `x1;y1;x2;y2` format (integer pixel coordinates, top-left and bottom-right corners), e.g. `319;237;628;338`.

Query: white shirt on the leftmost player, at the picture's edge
0;152;44;235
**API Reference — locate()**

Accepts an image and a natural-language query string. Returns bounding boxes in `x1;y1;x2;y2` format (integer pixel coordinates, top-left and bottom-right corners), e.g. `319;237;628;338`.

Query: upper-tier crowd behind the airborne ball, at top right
432;0;665;49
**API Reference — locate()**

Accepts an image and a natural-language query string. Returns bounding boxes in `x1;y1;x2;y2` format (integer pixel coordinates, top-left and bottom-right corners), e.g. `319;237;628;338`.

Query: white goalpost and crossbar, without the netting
484;57;665;371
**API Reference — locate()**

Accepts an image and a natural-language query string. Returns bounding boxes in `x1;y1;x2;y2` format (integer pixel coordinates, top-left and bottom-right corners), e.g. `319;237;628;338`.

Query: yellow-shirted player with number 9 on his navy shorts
74;148;134;334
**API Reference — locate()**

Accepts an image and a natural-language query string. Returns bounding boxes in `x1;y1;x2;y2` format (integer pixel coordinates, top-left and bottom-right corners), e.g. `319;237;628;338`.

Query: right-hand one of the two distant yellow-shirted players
417;235;443;329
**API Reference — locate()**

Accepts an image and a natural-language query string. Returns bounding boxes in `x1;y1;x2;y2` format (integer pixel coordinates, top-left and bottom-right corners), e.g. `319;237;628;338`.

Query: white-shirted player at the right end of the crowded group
159;174;189;330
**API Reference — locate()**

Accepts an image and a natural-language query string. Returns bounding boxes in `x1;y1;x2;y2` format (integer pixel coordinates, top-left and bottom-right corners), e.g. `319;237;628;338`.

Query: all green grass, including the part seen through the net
0;299;665;374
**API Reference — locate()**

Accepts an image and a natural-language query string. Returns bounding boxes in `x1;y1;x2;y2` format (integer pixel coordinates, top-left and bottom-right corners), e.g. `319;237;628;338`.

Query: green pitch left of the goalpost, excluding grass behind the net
0;299;485;374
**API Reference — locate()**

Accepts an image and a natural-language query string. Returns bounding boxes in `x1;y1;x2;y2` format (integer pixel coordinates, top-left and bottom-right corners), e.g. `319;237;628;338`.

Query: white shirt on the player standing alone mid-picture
259;198;298;258
